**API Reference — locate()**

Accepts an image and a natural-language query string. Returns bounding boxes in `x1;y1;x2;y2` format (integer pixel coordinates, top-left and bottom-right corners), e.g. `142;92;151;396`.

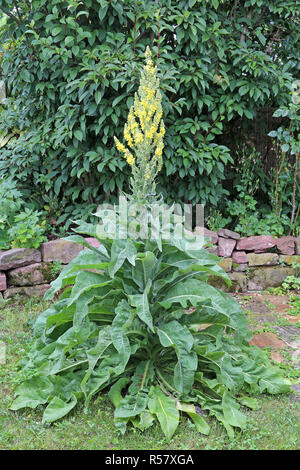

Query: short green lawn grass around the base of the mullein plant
0;299;300;450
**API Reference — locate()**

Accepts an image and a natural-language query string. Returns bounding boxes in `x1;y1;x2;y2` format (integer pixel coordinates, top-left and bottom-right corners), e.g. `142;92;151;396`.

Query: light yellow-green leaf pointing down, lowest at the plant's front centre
148;387;179;442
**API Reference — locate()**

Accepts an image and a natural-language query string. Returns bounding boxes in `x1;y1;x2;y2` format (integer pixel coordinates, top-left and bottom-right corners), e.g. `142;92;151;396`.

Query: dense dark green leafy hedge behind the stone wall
0;0;300;235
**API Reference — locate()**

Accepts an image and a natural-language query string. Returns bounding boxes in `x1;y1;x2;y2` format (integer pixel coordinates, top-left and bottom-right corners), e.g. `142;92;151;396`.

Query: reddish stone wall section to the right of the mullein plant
204;229;300;292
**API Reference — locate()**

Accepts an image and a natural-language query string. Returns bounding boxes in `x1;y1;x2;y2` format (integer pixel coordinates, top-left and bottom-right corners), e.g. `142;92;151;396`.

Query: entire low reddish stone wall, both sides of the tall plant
0;229;300;299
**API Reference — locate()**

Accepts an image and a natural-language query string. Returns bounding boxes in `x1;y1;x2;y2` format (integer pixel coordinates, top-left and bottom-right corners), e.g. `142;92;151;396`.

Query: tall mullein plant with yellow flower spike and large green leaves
10;50;290;441
